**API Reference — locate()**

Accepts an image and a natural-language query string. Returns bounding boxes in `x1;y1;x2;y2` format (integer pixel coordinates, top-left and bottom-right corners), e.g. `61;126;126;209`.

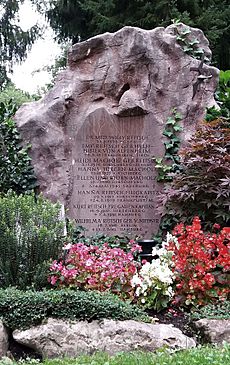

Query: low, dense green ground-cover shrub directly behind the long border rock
0;288;149;329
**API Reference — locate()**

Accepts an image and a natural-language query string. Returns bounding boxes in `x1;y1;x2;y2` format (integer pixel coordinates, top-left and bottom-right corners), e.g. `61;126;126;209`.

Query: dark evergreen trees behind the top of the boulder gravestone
35;0;230;69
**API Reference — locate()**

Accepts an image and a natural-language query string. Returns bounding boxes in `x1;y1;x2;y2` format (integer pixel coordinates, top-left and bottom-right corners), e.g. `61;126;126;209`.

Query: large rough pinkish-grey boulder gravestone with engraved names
15;24;218;238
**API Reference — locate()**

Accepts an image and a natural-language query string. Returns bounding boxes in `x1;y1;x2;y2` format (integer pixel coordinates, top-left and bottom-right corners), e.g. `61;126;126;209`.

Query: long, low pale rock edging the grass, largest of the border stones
13;318;195;358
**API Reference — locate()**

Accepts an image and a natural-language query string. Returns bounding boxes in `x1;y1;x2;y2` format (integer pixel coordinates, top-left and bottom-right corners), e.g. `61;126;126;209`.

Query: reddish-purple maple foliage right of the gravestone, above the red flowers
164;118;230;228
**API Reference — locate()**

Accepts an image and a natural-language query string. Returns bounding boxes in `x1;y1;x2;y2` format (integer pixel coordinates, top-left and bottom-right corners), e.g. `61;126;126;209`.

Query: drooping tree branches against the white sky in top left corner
0;0;38;89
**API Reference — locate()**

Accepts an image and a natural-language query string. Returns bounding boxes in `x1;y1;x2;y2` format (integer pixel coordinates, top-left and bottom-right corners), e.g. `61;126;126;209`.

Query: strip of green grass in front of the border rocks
0;344;230;365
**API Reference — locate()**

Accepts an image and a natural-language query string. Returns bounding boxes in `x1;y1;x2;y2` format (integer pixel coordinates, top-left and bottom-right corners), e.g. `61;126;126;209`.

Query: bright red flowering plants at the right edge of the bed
166;217;230;305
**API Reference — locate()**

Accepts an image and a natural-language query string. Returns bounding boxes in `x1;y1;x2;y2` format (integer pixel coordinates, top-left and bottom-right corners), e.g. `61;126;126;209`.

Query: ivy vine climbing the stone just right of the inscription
153;109;182;181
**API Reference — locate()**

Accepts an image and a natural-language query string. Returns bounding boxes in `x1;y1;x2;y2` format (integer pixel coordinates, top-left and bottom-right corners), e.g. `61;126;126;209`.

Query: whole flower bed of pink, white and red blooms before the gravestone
49;217;230;311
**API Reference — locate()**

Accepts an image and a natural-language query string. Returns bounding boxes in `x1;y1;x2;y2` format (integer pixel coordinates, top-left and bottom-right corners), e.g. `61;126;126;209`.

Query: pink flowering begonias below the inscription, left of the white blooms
48;241;141;298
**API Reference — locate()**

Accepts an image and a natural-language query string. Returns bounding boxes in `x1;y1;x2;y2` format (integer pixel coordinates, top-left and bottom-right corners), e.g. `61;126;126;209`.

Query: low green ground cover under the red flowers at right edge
190;300;230;319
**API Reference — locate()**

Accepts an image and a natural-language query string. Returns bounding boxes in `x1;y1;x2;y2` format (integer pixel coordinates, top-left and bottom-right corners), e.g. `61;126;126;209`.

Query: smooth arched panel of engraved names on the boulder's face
70;109;163;237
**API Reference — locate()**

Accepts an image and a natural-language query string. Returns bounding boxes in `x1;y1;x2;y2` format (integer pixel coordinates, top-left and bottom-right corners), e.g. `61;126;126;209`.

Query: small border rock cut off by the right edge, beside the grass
194;318;230;344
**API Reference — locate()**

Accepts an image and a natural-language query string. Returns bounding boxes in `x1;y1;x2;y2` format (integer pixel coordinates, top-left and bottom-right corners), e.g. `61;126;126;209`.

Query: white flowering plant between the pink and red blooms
131;243;174;311
